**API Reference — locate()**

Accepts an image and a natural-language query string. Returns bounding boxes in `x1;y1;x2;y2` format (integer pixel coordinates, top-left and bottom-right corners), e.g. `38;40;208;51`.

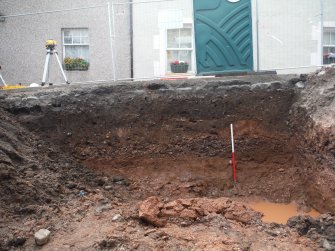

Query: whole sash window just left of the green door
166;24;193;71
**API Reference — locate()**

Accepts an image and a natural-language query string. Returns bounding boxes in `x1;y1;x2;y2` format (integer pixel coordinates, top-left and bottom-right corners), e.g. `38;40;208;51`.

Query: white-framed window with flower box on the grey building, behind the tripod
63;29;89;71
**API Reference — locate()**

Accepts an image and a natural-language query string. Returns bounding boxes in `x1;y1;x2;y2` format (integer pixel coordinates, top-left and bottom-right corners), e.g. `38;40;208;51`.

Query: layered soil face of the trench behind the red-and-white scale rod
3;73;335;218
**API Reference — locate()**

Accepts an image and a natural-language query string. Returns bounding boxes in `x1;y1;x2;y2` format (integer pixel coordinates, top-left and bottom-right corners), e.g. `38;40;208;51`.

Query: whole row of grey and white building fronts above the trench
0;0;335;84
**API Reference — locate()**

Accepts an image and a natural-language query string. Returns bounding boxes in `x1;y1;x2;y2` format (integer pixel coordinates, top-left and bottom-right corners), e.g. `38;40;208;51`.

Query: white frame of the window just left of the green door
164;21;195;74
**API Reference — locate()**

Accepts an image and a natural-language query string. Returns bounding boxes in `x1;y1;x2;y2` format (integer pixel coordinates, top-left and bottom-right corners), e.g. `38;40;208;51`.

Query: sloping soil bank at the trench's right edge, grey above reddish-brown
291;67;335;213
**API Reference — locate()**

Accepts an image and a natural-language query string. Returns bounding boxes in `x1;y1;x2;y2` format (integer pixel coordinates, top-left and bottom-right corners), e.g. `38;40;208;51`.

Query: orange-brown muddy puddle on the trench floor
249;201;320;224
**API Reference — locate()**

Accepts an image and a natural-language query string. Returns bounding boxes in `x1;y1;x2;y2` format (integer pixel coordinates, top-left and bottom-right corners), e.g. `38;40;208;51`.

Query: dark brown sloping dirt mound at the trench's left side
0;109;101;250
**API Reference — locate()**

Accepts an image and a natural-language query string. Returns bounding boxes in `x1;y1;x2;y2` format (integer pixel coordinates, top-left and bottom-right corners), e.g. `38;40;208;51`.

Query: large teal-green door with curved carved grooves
194;0;253;75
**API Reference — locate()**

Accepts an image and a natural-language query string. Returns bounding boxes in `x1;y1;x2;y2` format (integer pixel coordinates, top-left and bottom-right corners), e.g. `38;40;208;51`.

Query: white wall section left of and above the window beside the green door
133;0;193;78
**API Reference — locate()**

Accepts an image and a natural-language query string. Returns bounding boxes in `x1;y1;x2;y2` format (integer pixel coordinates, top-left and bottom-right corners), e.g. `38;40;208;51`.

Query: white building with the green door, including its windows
133;0;335;78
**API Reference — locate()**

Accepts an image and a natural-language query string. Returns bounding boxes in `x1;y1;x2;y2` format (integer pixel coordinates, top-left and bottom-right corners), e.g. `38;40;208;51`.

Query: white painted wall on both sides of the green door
134;0;335;78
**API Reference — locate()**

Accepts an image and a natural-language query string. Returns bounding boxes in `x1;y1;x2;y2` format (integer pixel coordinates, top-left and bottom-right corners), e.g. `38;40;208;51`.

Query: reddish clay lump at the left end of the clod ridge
139;196;166;227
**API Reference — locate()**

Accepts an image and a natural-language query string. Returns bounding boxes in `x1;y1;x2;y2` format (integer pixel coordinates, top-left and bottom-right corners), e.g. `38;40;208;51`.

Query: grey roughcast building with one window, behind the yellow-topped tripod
0;0;130;84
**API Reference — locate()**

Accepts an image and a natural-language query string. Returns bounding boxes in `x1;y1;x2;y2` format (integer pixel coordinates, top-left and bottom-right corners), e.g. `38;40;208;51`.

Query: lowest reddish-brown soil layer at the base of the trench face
87;156;304;203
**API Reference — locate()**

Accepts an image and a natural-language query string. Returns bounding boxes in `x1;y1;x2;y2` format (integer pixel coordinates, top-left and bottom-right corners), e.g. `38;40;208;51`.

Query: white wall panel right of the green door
258;0;322;71
